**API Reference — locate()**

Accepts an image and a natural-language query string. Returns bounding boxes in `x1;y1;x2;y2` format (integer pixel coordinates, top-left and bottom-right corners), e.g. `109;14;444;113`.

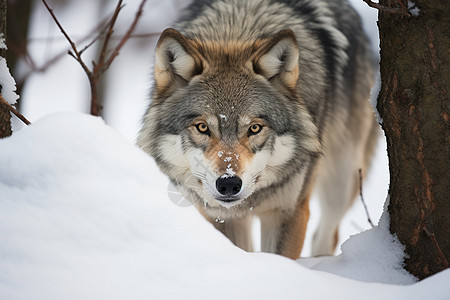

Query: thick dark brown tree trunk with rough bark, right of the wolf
378;0;450;279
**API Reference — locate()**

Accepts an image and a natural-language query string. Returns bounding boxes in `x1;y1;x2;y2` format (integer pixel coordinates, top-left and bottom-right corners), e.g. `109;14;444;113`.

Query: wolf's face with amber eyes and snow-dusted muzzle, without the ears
158;74;295;206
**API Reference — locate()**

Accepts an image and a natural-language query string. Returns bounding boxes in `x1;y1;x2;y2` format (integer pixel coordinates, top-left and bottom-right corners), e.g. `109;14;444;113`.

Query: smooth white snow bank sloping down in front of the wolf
0;113;450;300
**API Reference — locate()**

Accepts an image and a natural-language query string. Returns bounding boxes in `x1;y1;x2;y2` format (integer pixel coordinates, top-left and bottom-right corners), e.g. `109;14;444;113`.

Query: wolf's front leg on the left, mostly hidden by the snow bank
211;216;253;252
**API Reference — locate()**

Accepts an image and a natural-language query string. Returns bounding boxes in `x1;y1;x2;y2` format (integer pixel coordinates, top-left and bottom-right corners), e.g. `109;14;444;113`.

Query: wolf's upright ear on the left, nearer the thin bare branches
154;28;202;91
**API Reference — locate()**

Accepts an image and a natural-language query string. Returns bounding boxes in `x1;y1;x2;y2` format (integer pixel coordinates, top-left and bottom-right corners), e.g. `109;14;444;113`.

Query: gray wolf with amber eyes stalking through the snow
137;0;378;259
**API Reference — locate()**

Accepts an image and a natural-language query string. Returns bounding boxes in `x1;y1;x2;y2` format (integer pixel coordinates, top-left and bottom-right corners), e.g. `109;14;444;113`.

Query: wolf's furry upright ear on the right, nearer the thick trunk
253;29;299;88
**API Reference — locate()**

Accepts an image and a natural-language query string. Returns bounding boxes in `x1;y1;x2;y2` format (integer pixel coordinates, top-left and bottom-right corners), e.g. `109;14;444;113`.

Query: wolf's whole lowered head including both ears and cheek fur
138;29;320;207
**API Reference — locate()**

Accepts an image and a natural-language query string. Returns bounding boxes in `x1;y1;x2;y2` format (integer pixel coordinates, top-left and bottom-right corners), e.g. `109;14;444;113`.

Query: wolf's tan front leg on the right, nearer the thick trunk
260;197;309;259
